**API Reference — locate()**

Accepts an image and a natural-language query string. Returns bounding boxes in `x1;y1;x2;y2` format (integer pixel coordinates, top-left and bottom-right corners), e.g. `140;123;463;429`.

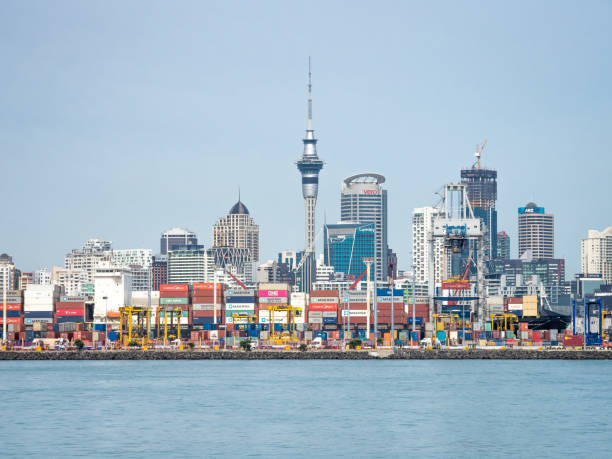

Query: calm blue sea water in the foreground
0;361;612;458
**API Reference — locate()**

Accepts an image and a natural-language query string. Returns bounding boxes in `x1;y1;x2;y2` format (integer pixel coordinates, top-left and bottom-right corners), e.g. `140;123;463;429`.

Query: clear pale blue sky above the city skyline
0;0;612;278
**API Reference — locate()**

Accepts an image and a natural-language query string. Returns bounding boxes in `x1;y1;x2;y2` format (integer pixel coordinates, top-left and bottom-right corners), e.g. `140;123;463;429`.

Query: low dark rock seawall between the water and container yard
0;349;612;361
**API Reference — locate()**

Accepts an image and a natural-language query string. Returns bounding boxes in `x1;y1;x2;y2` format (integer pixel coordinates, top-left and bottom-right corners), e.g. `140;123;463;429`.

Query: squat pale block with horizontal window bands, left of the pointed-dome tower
168;245;208;284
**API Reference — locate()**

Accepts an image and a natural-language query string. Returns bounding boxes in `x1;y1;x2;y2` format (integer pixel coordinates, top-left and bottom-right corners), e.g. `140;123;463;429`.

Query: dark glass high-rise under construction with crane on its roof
461;146;497;264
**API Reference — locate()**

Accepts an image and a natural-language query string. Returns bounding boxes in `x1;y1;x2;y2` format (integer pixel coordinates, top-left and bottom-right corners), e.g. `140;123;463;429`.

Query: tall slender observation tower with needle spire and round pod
297;61;323;293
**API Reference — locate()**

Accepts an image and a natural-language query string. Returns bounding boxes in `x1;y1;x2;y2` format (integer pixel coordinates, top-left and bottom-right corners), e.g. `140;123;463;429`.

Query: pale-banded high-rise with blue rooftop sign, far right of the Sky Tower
518;202;555;260
